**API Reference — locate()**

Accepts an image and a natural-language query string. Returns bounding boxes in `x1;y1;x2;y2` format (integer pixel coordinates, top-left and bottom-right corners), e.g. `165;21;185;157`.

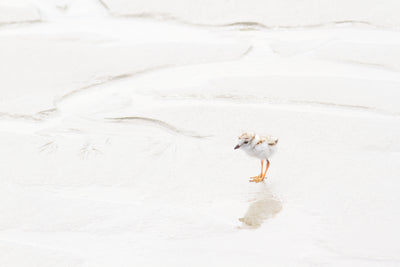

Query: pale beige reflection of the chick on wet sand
239;183;282;229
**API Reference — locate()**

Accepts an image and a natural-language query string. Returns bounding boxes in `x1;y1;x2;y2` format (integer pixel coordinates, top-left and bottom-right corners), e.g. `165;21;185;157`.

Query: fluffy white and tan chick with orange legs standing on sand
234;132;278;183
